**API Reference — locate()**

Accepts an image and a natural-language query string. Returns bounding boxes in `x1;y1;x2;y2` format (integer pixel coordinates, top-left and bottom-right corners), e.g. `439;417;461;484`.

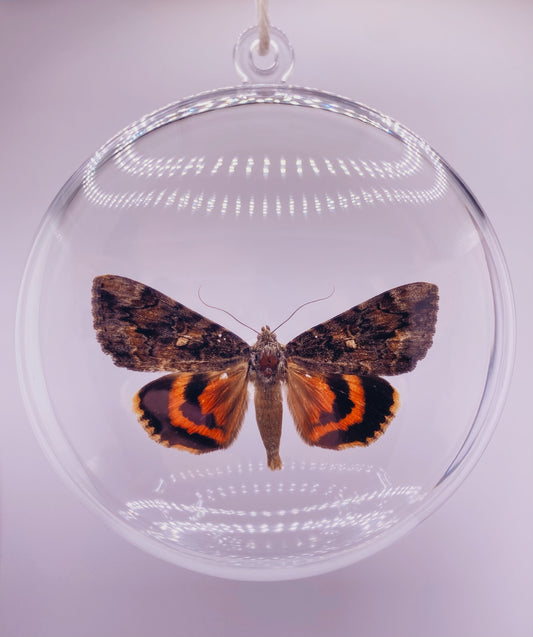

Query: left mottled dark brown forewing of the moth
92;274;250;372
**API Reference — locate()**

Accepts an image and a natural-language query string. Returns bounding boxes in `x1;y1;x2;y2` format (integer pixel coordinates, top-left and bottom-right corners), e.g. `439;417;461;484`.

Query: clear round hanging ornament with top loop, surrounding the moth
17;29;514;580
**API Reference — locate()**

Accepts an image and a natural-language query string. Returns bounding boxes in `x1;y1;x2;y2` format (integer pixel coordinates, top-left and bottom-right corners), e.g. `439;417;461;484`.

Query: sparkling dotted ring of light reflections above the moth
83;87;448;221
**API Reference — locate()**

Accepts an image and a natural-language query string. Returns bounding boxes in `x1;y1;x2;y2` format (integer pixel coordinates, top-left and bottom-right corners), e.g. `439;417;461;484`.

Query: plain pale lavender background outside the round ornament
0;0;533;637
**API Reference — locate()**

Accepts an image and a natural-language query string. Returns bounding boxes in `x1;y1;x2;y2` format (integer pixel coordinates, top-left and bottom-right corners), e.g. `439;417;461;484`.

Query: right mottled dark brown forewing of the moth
286;283;439;376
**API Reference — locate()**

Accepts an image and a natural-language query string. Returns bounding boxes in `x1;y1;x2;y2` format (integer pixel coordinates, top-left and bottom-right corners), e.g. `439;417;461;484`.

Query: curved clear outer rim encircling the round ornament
16;84;515;581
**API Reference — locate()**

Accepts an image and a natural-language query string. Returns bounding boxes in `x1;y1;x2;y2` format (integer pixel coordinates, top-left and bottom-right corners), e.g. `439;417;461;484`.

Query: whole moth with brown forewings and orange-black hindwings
92;275;438;470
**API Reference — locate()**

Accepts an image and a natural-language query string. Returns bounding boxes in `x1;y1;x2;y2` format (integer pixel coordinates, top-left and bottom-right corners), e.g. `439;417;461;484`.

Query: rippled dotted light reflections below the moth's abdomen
121;462;426;564
